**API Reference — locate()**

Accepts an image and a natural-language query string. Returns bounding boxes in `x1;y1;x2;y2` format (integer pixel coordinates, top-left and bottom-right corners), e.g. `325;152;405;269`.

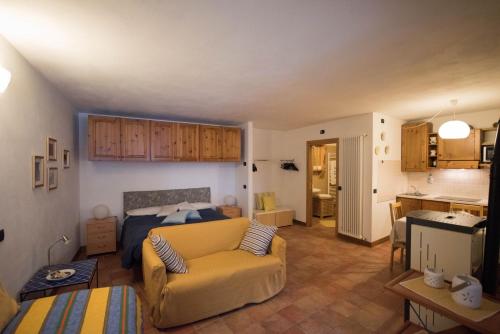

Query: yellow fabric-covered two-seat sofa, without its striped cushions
142;218;286;328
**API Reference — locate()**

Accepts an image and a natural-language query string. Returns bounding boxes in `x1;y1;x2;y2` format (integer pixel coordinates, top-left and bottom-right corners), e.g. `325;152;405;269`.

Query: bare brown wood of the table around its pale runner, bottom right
385;269;500;334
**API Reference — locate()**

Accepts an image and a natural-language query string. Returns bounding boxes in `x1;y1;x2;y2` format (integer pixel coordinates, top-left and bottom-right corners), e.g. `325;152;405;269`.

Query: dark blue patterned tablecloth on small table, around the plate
20;259;97;294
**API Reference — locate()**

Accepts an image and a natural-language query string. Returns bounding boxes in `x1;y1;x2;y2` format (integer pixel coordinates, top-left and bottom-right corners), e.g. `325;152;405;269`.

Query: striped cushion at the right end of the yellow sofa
240;221;278;256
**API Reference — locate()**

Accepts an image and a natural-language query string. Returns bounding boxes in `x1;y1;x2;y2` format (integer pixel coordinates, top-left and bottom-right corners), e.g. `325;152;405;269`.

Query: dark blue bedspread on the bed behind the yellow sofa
120;209;229;269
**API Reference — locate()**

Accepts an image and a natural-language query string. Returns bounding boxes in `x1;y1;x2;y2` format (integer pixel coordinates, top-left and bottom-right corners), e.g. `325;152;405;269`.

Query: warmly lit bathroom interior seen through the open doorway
311;144;337;228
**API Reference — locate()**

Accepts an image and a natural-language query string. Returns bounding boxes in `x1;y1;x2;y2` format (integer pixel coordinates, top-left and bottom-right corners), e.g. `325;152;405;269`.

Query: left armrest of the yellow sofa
142;238;167;319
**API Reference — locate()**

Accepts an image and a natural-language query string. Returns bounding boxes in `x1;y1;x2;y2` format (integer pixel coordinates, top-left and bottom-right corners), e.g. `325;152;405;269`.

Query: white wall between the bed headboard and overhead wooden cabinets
78;113;238;244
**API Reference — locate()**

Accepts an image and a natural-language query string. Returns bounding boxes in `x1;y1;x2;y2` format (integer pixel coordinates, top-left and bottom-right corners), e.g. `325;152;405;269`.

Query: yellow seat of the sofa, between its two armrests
167;249;282;291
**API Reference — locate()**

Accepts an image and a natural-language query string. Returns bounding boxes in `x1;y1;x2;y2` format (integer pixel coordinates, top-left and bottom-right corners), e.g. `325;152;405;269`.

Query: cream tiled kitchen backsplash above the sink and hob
407;169;490;199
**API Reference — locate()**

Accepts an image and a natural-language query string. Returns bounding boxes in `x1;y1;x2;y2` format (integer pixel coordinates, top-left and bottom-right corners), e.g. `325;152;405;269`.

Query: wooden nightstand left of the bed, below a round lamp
87;217;118;256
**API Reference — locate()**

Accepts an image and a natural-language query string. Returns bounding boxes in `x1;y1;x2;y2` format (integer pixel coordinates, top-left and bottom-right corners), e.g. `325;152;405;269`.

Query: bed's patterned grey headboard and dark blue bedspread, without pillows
120;188;229;269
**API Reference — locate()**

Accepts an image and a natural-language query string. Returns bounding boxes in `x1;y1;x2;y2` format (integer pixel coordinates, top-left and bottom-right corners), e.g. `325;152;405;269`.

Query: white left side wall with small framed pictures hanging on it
0;37;80;295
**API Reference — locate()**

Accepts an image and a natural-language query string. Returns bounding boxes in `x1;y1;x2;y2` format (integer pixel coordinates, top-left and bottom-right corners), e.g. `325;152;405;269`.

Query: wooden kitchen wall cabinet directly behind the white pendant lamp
437;129;481;168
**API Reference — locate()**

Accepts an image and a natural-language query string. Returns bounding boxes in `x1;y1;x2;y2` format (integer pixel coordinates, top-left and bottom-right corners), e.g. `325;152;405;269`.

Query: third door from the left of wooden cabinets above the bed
150;121;177;161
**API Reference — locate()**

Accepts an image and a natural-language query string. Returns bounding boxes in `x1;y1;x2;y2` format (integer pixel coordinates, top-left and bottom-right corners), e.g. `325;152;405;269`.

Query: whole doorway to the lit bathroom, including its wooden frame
306;138;339;232
